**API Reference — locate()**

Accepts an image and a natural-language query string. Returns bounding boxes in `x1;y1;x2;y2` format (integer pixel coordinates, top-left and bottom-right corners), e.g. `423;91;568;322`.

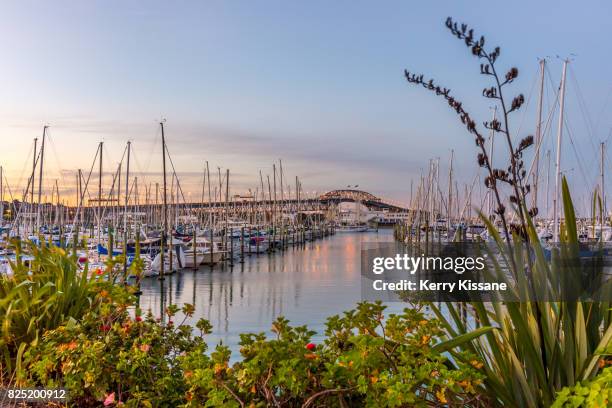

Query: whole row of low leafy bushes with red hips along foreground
20;286;486;407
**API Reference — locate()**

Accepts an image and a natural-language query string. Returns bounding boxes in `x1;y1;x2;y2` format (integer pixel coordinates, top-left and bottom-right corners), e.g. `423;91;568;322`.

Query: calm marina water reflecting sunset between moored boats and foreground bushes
140;230;400;358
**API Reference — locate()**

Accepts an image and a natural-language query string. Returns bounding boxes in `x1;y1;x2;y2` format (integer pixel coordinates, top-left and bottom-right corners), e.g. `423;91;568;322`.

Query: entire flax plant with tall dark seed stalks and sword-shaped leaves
404;18;612;408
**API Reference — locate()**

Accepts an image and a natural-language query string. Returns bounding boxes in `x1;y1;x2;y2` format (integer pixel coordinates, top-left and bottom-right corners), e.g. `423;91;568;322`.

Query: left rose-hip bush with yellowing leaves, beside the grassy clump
20;286;206;407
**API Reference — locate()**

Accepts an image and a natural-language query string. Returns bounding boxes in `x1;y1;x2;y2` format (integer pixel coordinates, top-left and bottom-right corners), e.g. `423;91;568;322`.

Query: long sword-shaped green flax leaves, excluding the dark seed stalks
431;179;612;408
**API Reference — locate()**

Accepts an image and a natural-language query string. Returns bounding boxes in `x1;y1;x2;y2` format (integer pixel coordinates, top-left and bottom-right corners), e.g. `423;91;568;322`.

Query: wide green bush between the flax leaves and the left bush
183;303;486;407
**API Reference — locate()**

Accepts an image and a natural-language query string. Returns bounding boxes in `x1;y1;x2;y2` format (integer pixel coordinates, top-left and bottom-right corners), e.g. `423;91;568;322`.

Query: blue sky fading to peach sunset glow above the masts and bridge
0;0;612;214
